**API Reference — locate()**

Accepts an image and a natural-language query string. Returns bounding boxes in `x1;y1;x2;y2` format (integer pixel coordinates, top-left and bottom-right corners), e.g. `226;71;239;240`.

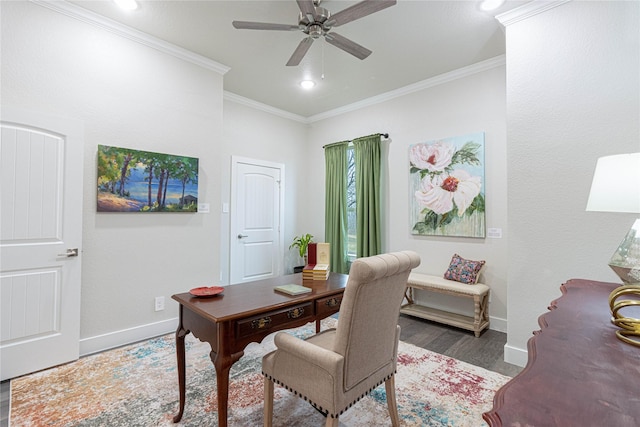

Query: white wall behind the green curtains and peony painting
299;66;508;329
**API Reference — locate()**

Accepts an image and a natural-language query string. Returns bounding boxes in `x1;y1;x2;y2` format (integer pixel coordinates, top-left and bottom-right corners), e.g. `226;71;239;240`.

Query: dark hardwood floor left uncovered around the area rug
0;314;522;427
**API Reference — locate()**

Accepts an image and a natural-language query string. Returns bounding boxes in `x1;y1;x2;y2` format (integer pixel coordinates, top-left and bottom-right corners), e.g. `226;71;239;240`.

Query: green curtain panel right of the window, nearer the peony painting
353;134;382;258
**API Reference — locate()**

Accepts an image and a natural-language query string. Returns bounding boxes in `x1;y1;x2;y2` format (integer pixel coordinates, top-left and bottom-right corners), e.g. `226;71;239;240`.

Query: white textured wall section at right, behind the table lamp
505;1;640;365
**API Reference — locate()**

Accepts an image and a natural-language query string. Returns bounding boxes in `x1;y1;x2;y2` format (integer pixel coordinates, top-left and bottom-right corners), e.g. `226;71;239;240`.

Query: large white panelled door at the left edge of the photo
0;107;83;380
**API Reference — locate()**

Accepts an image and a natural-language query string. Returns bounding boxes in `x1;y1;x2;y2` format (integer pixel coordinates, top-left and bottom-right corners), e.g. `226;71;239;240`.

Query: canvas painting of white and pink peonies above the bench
409;132;486;238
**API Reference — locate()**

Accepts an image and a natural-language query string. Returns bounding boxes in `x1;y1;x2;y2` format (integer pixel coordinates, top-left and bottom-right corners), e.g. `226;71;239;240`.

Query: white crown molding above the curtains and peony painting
307;55;506;123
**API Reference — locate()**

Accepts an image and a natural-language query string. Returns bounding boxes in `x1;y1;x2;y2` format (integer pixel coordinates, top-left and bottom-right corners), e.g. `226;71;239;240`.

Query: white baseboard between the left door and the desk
80;317;178;357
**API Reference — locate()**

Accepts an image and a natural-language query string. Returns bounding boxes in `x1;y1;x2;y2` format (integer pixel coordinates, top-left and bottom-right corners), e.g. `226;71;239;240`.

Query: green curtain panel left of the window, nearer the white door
324;141;349;273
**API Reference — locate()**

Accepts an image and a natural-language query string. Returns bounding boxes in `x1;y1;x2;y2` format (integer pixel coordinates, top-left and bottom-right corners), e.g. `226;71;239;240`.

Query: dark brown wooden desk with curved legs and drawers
172;273;349;427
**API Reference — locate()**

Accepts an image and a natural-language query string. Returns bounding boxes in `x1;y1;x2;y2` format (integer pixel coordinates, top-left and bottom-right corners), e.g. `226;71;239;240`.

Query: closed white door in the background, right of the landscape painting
230;156;284;284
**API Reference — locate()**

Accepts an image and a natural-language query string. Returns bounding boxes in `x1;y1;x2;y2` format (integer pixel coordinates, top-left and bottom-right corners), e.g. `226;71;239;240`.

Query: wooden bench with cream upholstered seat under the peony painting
400;273;489;337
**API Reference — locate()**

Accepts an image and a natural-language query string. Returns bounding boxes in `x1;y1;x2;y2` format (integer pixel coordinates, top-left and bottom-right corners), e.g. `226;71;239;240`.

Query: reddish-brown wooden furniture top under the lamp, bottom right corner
482;279;640;427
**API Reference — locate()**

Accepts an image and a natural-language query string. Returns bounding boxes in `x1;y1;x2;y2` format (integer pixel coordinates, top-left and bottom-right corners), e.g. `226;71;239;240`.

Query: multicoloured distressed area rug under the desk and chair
9;318;510;427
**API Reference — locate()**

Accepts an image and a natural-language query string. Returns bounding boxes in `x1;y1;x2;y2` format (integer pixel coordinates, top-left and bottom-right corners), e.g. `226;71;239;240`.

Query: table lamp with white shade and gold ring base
587;153;640;346
